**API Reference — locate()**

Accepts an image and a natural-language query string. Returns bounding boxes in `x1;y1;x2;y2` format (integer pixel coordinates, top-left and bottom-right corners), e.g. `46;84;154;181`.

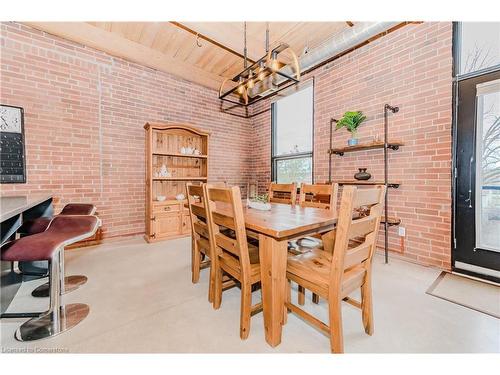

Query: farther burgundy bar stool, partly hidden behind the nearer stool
18;203;96;297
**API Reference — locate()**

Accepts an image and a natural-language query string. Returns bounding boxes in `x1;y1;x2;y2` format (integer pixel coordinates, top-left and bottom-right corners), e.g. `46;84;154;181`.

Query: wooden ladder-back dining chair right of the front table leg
284;186;385;353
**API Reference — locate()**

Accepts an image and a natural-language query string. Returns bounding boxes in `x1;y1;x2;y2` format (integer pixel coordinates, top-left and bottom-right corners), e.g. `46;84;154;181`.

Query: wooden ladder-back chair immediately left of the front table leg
204;185;262;339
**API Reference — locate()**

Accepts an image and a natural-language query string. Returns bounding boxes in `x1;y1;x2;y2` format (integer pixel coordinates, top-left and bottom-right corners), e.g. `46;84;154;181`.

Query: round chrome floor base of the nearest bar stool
14;303;90;341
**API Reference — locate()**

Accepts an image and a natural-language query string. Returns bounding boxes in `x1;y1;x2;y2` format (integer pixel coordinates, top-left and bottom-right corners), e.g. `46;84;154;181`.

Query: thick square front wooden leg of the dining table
259;234;288;347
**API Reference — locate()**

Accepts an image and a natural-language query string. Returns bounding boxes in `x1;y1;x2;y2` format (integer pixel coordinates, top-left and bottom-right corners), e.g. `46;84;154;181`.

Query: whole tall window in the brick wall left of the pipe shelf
271;84;314;184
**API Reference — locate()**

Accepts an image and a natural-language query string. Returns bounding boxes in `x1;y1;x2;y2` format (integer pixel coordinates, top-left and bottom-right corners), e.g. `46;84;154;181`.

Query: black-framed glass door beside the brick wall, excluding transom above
452;71;500;281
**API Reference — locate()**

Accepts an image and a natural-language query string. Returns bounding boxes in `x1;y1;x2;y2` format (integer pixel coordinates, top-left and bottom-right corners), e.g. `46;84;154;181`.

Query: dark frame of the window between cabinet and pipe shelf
271;78;315;184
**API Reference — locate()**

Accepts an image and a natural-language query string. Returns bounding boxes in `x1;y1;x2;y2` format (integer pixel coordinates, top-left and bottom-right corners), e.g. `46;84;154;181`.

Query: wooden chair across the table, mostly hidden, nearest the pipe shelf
295;183;339;305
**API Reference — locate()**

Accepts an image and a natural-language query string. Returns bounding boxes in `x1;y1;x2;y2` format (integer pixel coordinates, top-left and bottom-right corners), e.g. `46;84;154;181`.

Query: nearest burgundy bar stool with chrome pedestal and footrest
1;216;101;341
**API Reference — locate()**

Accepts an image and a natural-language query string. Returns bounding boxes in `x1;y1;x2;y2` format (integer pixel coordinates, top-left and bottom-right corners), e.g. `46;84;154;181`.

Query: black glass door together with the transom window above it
452;22;500;282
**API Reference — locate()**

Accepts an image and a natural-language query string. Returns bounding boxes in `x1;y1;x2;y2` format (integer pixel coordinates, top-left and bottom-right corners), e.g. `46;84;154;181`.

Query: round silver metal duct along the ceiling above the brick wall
249;22;401;97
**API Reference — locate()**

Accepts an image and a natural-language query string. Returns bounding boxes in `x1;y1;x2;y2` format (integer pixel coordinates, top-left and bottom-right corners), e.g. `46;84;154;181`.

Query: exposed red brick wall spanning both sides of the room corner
0;23;452;268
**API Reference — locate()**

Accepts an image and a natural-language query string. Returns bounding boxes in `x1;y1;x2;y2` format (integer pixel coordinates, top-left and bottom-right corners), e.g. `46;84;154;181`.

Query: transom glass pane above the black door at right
460;22;500;74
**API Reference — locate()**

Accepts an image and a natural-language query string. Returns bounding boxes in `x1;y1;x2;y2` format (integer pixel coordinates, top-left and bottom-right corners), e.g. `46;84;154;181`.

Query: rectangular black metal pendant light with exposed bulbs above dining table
219;22;300;107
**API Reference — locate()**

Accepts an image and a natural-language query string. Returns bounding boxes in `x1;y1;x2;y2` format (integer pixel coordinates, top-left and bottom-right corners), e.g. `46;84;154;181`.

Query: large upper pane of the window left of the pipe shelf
274;86;313;156
